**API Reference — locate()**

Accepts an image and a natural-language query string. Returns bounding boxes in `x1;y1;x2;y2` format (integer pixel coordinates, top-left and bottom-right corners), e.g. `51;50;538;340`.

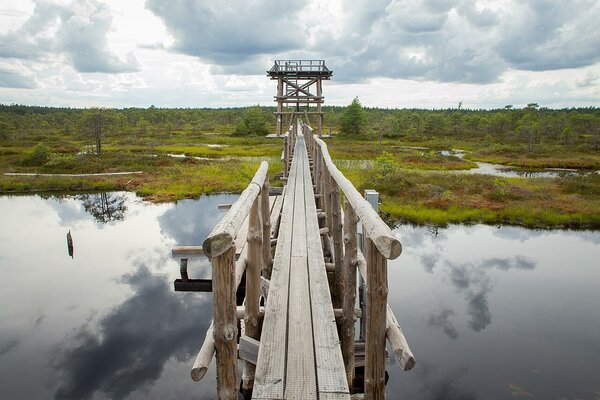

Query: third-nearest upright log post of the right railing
329;178;344;308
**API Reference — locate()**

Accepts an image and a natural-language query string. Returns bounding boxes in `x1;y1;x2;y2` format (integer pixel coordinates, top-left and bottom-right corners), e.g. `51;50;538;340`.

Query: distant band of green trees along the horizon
0;102;600;151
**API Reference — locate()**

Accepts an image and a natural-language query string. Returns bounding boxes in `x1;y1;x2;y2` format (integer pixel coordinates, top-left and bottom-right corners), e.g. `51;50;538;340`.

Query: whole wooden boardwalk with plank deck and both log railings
174;120;415;400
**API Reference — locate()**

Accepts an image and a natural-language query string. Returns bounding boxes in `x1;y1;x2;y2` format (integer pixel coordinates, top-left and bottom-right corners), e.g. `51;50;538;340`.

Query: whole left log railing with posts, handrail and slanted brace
198;161;271;399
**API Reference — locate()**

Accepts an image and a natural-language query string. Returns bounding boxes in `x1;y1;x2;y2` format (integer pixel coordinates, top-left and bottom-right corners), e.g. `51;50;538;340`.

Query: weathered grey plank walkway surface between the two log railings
253;135;350;400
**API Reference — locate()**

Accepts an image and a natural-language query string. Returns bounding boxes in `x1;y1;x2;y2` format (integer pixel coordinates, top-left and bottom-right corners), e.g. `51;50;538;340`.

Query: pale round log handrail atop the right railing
313;135;402;260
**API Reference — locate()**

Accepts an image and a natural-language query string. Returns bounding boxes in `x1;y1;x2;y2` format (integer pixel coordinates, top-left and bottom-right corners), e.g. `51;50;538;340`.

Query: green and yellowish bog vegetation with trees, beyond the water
0;98;600;227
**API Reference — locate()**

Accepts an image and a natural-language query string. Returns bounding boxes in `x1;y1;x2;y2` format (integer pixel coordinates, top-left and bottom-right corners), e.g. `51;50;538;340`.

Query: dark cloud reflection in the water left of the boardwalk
53;266;212;399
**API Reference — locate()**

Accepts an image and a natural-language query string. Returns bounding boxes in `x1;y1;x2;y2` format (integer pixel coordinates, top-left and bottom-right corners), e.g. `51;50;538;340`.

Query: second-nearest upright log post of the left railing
242;198;268;392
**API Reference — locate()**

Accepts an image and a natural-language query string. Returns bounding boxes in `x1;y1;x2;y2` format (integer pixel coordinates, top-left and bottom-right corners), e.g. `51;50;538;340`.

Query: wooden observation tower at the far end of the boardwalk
267;60;333;136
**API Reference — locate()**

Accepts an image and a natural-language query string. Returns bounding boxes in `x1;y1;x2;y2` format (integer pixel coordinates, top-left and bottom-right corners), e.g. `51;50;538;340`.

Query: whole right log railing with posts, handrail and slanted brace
302;125;415;399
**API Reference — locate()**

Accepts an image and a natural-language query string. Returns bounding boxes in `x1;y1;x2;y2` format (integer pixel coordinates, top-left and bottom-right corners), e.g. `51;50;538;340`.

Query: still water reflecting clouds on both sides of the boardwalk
0;193;600;400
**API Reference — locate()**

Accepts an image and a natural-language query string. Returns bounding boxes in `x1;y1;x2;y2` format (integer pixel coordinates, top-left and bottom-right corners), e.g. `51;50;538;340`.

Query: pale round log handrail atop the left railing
202;161;269;257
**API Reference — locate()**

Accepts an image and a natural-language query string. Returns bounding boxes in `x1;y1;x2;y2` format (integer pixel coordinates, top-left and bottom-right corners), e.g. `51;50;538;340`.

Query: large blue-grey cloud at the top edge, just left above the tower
146;0;306;65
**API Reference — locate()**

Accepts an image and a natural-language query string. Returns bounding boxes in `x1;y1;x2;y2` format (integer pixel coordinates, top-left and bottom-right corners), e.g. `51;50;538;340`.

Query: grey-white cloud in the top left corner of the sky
0;0;139;73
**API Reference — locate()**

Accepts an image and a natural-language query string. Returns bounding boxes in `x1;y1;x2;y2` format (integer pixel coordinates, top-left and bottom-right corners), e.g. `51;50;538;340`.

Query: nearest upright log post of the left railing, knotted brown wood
212;245;238;400
